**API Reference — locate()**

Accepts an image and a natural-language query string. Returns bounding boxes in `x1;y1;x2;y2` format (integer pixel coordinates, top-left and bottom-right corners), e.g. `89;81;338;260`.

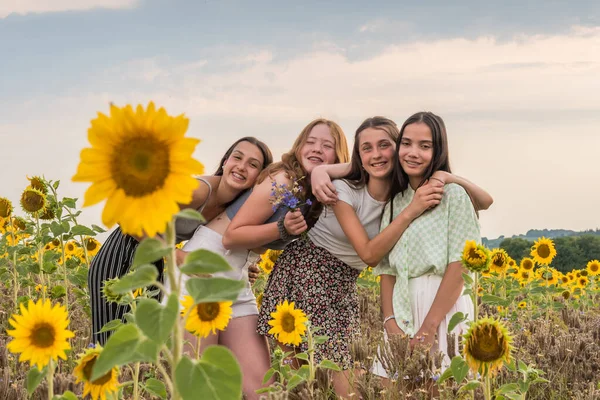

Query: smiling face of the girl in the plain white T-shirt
358;128;396;178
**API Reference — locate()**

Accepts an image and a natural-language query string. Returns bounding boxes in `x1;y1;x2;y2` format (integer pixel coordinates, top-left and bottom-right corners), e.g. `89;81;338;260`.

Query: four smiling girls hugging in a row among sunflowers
88;112;493;399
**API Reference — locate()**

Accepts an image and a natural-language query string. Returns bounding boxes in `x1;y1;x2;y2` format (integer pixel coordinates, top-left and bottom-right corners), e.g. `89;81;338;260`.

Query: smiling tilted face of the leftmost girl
223;141;264;190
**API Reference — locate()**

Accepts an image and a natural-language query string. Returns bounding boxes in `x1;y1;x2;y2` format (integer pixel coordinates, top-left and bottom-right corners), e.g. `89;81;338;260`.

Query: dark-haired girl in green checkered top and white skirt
374;112;481;376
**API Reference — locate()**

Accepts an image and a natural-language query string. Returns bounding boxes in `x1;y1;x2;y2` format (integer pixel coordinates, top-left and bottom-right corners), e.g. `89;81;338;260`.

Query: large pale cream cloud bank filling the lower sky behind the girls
0;28;600;237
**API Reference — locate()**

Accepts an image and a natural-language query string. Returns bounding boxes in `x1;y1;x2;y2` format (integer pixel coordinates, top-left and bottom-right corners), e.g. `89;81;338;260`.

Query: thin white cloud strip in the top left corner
0;0;140;19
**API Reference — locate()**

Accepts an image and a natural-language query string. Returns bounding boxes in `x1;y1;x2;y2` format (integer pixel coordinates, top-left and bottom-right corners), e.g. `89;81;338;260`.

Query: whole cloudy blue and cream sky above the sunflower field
0;0;600;238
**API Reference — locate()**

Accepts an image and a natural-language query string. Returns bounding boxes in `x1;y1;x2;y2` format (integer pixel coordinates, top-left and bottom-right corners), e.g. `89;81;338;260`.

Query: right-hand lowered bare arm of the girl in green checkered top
410;261;468;344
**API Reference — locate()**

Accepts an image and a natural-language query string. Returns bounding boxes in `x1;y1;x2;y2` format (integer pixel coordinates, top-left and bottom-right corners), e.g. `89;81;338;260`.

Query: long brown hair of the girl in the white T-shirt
343;116;400;189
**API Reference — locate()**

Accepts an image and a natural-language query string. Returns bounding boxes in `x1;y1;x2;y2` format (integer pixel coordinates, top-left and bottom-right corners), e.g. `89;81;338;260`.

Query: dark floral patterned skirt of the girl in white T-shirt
257;239;360;369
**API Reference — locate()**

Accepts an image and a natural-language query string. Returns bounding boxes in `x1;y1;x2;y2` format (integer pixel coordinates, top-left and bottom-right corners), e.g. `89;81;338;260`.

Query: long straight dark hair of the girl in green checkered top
390;111;452;222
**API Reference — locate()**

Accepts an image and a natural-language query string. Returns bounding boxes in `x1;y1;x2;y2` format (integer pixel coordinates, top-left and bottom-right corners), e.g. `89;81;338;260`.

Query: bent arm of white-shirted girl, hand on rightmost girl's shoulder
333;184;443;267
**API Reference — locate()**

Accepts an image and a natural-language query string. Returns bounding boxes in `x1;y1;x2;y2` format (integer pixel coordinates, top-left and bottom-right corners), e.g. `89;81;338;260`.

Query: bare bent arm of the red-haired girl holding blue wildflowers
223;173;307;249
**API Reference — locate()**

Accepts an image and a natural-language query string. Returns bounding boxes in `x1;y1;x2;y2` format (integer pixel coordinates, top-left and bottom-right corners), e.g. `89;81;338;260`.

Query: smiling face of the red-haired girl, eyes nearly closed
298;124;336;175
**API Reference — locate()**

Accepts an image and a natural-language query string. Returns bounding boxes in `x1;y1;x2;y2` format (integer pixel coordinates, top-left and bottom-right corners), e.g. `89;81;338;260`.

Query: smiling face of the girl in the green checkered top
398;122;433;186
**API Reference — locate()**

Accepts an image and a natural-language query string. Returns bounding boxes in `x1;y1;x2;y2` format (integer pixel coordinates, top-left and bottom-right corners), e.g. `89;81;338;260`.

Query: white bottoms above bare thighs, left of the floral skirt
163;225;260;318
